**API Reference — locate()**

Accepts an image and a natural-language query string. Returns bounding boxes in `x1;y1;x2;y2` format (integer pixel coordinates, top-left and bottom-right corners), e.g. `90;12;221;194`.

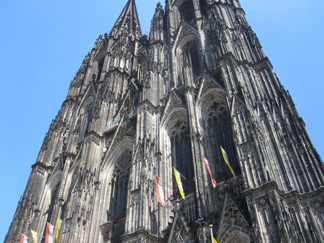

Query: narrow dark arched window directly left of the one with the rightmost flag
171;122;194;194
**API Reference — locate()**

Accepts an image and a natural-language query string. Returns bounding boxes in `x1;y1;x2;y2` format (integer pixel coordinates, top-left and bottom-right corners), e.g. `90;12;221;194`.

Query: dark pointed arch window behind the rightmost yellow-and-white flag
208;102;240;179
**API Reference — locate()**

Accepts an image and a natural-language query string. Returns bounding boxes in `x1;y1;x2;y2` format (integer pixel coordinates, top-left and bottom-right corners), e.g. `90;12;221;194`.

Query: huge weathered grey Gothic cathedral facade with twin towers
5;0;324;243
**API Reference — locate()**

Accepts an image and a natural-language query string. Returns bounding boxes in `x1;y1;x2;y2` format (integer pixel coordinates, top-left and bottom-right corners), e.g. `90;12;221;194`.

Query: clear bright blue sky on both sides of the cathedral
0;0;324;241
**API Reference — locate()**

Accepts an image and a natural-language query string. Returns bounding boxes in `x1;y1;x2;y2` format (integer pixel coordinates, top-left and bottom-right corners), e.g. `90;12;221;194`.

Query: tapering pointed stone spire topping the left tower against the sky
110;0;142;39
